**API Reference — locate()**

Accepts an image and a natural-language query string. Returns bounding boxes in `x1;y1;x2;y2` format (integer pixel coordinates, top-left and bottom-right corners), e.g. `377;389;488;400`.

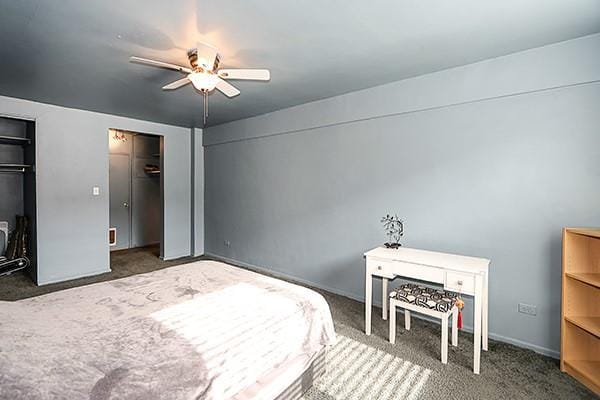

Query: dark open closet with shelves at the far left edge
0;116;37;283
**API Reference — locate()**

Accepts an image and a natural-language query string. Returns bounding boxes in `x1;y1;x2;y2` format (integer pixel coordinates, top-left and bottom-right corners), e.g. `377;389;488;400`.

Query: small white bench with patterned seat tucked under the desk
389;283;459;364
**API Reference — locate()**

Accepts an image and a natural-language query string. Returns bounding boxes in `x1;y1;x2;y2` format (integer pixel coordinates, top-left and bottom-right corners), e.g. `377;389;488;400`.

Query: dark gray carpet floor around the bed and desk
0;247;597;400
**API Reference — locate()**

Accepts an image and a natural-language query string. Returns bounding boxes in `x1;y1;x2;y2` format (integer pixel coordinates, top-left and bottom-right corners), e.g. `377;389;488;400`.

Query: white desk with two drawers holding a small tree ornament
365;247;490;374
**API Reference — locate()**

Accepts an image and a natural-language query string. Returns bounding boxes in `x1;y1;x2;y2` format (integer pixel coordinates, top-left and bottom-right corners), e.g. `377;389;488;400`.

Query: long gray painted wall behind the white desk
204;35;600;356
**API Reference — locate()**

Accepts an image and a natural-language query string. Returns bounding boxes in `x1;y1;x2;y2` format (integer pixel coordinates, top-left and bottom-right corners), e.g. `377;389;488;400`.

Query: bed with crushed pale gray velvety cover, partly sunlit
0;261;335;400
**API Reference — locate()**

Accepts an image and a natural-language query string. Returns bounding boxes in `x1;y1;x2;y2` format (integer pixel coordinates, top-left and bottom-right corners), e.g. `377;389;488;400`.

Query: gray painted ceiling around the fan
0;0;600;126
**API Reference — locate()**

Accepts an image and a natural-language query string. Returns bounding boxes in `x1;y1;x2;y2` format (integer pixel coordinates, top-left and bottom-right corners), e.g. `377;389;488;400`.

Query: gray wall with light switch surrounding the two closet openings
0;96;192;284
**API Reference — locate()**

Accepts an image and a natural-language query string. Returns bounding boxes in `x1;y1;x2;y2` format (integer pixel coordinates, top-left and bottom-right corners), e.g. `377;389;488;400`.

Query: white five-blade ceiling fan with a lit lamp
129;42;271;124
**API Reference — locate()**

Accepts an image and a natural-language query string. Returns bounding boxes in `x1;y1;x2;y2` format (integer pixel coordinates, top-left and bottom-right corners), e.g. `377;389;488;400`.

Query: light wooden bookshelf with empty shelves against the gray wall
560;228;600;395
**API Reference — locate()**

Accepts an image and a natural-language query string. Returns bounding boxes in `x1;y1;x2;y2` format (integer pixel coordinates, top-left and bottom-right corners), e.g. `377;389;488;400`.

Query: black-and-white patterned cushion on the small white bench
390;283;458;312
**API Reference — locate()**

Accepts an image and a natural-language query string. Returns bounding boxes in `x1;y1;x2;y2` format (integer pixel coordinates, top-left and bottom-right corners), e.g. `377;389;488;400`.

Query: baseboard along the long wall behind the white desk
204;252;560;359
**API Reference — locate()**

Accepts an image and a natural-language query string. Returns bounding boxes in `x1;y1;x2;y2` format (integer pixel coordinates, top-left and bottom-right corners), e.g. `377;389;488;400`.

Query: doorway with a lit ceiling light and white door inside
108;129;163;258
